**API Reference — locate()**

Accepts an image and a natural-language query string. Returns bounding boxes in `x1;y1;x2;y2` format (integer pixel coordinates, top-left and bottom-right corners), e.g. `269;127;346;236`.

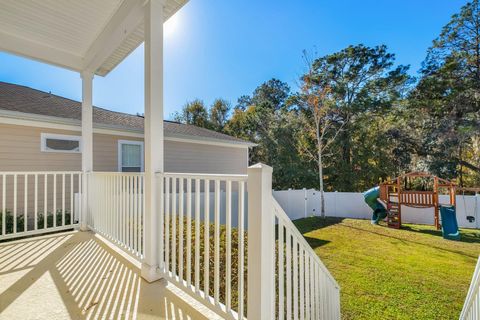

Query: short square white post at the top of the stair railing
247;163;275;319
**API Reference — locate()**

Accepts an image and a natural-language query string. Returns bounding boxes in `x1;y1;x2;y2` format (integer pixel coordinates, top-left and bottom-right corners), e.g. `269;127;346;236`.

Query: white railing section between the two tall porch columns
87;172;145;258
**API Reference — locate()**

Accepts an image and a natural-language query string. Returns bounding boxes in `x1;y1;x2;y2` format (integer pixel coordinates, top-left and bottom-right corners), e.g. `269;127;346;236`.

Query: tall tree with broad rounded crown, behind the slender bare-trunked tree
311;45;410;191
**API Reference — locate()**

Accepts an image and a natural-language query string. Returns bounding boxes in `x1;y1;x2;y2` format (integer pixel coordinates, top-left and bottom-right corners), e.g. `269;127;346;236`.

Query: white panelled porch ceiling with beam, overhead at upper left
0;0;188;76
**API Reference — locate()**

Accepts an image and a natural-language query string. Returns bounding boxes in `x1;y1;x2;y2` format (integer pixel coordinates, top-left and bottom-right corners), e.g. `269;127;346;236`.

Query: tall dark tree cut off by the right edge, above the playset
410;0;480;185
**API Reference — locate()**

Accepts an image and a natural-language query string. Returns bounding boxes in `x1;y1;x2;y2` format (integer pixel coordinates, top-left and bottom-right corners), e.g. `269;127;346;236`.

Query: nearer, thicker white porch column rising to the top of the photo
142;0;165;282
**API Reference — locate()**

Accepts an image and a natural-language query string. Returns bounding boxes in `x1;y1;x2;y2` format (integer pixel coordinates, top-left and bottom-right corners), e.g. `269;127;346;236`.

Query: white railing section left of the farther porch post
0;171;82;240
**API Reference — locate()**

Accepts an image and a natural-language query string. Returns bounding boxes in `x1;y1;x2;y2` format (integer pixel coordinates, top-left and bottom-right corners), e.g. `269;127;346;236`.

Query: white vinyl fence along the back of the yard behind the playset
273;189;480;228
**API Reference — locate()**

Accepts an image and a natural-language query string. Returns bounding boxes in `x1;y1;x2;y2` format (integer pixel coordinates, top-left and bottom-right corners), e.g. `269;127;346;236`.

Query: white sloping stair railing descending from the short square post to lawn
272;197;340;319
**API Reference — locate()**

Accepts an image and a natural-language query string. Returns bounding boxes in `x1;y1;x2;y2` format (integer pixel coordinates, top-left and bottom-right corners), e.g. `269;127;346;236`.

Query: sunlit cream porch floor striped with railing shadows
0;232;218;319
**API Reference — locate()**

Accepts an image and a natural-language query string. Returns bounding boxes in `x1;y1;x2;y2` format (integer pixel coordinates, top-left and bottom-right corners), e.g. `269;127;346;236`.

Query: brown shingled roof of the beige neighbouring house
0;81;254;146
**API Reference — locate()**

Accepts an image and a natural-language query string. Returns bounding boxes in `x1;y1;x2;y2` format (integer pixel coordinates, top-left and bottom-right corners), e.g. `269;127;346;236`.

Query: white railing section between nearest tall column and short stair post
157;173;247;319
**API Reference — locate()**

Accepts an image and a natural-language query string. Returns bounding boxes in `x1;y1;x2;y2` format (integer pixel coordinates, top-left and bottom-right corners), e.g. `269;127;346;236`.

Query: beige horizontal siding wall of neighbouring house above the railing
0;124;248;174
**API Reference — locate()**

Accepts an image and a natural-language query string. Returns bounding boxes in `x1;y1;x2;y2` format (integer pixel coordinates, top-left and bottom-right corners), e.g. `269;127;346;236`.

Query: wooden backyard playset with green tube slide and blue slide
364;172;466;240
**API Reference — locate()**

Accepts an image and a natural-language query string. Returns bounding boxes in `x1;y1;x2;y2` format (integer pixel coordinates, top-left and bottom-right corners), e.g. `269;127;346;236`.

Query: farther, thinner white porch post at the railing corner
80;71;93;231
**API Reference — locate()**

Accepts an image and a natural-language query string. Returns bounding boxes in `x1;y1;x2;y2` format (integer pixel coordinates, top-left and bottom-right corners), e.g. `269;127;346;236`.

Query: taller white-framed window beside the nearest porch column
118;140;143;172
